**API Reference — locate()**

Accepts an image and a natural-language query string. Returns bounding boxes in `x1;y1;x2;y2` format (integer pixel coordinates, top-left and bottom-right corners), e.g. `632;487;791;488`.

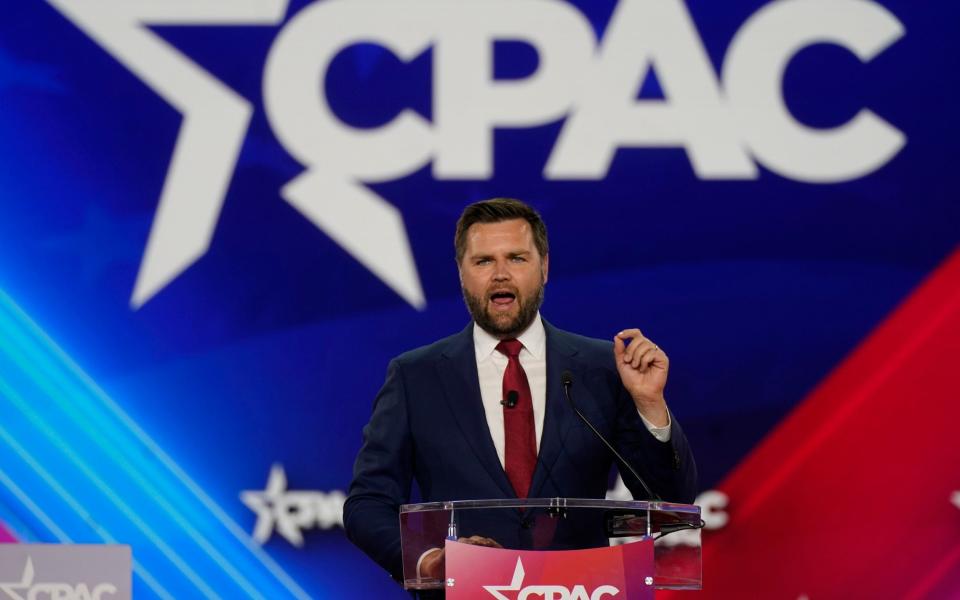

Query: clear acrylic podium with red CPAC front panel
400;498;703;600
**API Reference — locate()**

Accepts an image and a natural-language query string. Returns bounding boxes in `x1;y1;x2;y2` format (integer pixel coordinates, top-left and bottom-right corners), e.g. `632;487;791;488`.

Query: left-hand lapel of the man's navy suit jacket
437;323;516;498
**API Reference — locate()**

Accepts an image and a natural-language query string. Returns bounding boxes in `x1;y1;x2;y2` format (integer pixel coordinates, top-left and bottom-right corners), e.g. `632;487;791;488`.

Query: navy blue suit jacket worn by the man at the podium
343;321;697;579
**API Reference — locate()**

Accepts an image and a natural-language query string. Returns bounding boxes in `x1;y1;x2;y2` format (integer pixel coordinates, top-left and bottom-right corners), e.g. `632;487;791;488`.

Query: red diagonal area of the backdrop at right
658;250;960;600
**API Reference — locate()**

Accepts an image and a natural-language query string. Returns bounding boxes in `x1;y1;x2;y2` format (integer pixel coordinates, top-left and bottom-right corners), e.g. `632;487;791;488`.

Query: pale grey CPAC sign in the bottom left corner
0;544;132;600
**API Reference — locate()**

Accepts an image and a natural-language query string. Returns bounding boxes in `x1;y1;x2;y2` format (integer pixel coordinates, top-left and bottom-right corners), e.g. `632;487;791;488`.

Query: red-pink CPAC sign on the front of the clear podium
445;540;653;600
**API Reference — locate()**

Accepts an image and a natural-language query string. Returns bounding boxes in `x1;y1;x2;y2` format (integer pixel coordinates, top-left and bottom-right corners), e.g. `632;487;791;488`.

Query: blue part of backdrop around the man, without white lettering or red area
0;0;960;598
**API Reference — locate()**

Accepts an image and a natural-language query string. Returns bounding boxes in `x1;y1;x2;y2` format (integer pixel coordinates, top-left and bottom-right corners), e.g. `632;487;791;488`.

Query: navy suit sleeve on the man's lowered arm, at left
343;360;413;581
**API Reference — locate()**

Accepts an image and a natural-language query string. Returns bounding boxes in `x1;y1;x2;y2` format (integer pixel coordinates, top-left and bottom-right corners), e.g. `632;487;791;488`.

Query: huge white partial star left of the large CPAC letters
48;0;426;309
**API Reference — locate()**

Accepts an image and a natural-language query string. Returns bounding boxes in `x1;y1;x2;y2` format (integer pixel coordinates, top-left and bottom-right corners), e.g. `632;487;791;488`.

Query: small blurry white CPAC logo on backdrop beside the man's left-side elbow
240;464;346;548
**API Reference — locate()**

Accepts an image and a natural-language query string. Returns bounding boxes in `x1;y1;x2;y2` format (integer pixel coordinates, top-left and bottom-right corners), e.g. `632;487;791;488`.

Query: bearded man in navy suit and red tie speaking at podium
344;198;696;580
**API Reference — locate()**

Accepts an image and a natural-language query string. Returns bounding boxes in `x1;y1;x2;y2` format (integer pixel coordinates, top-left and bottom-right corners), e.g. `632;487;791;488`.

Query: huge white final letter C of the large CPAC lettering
723;0;906;183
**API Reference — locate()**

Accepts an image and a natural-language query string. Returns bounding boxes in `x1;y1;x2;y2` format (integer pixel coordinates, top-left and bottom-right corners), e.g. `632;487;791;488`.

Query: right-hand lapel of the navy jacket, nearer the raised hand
530;320;581;498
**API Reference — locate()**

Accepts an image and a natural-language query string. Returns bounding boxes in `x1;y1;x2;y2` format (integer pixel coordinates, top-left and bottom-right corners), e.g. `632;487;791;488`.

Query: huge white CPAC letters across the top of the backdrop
272;0;905;185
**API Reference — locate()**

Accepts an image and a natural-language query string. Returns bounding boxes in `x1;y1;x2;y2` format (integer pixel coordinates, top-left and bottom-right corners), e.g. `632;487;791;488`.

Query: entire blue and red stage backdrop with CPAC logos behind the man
0;0;960;599
